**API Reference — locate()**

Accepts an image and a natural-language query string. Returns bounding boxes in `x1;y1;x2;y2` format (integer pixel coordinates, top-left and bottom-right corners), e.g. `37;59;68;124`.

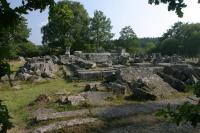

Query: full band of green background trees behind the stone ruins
0;0;200;58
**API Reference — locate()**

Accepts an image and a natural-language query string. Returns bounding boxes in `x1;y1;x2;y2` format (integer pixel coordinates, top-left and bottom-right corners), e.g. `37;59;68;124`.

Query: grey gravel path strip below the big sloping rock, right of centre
91;98;189;118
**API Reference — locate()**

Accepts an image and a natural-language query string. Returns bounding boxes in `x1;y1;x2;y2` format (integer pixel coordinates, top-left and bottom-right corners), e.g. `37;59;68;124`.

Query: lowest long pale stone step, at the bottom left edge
33;118;98;133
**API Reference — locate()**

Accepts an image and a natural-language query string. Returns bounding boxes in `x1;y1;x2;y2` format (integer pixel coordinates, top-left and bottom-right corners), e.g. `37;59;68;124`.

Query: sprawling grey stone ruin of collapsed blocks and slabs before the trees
3;48;200;99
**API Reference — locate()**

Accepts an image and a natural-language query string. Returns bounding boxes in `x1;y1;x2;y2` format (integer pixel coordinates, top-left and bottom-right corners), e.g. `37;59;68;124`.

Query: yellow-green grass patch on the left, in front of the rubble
0;78;88;132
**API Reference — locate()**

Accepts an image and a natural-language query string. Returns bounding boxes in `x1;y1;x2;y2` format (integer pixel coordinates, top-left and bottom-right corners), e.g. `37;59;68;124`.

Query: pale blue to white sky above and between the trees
15;0;200;45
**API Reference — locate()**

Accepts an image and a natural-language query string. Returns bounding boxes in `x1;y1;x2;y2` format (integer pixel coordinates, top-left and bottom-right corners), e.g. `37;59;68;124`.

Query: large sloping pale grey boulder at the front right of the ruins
116;67;177;99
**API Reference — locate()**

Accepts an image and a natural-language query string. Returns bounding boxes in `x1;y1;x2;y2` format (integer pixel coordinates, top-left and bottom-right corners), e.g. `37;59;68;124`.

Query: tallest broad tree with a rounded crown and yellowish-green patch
42;1;89;53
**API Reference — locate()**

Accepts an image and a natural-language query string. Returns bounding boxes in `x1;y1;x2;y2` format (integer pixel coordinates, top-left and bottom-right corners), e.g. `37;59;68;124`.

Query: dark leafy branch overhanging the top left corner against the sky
0;0;54;29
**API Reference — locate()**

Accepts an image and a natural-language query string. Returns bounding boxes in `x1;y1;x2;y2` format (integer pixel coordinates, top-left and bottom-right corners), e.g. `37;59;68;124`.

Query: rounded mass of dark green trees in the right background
156;22;200;56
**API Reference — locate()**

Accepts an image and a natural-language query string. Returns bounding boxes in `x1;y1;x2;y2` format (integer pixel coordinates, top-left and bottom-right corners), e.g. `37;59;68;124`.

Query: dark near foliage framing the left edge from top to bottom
0;0;54;133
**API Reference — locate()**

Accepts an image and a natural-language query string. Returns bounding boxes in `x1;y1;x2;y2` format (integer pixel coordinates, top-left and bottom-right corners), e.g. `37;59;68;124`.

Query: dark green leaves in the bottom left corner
0;100;13;133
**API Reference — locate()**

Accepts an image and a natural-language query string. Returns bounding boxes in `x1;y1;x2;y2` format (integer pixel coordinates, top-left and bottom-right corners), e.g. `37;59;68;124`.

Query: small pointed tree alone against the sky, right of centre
118;26;139;53
